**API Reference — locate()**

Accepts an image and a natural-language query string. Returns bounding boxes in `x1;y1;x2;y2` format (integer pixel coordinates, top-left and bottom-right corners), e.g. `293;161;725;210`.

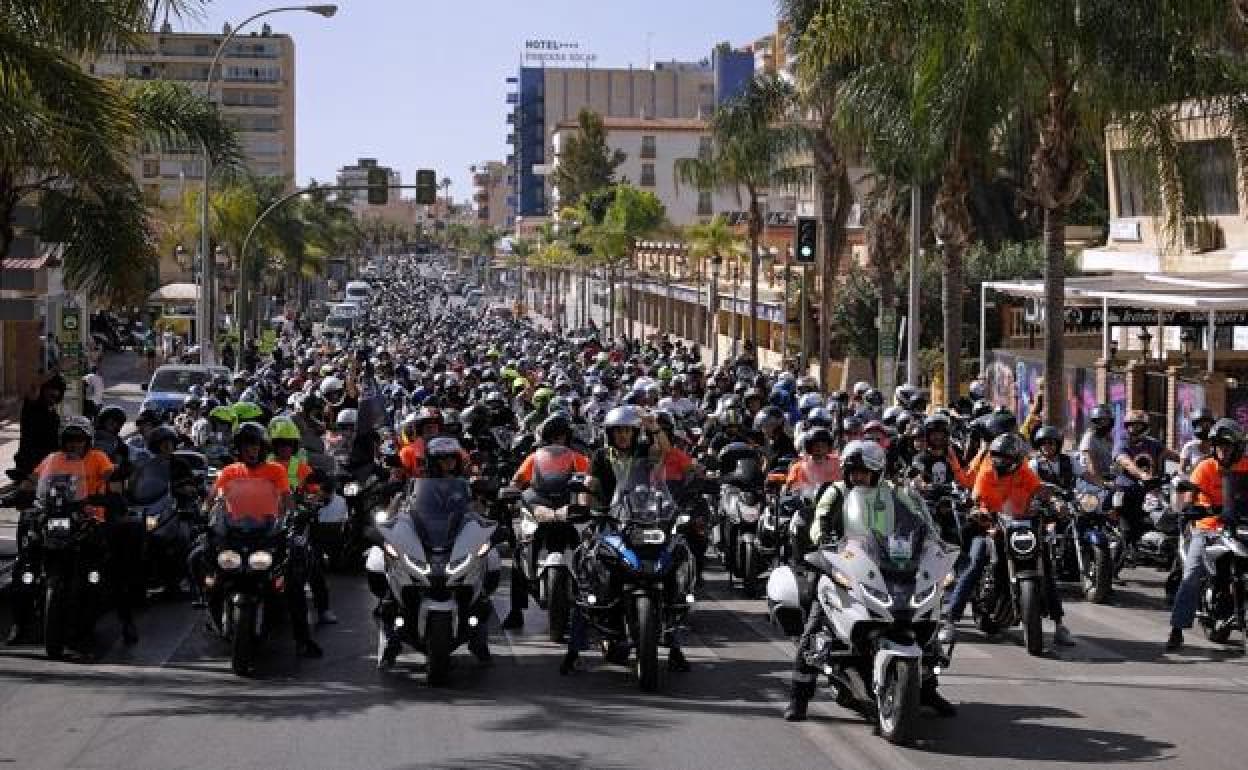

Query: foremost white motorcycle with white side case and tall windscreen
768;487;956;744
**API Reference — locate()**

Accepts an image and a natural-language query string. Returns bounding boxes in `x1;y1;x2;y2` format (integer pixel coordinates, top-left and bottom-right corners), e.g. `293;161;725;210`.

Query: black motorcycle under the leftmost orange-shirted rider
36;473;107;659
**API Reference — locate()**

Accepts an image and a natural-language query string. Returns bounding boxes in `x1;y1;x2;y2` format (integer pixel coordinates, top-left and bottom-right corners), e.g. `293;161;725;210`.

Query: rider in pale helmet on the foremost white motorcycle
784;441;956;721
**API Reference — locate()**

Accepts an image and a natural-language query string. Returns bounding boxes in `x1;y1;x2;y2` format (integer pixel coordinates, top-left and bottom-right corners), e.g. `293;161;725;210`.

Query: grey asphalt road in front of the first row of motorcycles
0;559;1248;770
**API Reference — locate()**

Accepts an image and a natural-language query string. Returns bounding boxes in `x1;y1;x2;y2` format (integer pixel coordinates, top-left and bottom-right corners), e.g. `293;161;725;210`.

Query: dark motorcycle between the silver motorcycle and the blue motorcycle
499;474;589;643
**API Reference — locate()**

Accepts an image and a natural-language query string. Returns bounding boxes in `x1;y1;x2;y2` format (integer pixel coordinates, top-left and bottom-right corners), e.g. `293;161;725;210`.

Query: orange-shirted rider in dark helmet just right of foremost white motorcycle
941;433;1075;646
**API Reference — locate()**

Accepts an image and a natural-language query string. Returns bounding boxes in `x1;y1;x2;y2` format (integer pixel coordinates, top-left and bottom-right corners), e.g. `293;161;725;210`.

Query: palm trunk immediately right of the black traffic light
801;159;854;392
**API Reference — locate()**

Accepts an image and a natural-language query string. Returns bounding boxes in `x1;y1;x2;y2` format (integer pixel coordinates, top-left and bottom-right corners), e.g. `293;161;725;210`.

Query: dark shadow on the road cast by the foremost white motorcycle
914;703;1177;765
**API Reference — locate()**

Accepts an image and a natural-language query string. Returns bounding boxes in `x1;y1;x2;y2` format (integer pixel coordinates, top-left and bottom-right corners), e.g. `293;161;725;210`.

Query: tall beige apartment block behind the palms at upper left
89;24;295;203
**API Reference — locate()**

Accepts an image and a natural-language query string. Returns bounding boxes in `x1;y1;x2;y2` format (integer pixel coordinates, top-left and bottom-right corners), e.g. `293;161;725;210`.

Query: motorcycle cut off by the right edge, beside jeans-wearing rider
1196;524;1248;655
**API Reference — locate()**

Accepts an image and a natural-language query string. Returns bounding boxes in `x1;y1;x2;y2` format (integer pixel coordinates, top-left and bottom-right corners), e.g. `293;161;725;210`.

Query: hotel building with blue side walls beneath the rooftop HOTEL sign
507;55;753;217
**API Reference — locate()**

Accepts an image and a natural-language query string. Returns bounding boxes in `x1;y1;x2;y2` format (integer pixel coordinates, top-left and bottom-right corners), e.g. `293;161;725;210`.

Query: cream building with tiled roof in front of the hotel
550;117;741;226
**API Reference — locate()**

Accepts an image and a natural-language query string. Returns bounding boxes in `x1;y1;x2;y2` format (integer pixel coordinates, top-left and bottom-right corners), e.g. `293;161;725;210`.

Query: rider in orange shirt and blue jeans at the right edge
1166;417;1248;651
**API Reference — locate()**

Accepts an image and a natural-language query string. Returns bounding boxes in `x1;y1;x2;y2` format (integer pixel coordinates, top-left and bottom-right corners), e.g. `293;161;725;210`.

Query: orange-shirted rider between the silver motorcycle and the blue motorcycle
503;414;589;629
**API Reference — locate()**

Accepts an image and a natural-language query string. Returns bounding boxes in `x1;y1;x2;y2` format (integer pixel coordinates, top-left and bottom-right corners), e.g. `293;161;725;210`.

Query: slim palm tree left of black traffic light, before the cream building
675;75;794;344
